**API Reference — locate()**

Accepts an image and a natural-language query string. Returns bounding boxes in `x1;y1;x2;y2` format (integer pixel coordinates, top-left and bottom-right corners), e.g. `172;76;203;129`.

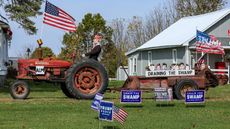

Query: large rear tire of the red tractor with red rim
66;59;109;99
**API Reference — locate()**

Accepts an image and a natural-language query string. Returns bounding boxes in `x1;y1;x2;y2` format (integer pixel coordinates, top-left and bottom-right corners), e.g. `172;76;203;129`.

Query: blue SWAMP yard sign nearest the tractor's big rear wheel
121;90;141;103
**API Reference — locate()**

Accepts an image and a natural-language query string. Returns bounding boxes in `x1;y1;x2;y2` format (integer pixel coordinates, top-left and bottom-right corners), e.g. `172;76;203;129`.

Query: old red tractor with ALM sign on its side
10;44;108;99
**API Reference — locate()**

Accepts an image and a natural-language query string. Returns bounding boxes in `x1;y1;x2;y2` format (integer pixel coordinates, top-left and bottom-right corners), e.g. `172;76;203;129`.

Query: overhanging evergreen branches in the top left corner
0;0;43;34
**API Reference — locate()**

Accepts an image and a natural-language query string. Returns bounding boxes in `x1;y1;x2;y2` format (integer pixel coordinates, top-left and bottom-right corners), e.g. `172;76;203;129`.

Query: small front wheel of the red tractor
10;81;30;99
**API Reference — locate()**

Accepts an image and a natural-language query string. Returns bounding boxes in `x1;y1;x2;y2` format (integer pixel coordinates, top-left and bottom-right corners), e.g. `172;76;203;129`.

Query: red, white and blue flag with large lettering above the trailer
196;30;224;55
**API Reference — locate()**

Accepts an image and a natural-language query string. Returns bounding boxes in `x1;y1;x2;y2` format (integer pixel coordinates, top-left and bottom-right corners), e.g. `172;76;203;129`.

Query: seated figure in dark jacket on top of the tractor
82;34;102;61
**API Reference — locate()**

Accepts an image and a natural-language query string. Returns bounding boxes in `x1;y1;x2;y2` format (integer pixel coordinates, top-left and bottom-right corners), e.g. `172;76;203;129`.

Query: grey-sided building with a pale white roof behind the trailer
126;8;230;75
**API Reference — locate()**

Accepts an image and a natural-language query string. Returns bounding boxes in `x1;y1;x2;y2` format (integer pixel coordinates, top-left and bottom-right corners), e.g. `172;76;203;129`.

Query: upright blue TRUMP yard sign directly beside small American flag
99;100;113;121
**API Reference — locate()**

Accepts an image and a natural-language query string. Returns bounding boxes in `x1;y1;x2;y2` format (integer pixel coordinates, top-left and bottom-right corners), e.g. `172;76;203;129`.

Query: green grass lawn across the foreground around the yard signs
0;82;230;129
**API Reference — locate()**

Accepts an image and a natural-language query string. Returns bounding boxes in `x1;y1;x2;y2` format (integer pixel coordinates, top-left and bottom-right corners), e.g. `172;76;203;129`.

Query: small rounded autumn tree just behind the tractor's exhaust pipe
31;47;55;58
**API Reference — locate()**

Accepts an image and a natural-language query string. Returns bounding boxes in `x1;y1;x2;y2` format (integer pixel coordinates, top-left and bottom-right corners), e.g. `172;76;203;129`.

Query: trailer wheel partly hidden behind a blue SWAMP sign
174;79;198;100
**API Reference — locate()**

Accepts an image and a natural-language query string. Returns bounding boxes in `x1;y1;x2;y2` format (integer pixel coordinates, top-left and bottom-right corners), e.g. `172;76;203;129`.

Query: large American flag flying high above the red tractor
43;1;76;32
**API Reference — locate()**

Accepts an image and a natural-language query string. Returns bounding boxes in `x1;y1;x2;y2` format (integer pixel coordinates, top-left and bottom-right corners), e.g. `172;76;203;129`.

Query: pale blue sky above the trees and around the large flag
6;0;162;57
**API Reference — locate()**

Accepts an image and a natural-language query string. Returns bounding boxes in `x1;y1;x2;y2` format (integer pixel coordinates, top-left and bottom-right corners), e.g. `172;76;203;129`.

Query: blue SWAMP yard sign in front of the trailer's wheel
185;90;204;103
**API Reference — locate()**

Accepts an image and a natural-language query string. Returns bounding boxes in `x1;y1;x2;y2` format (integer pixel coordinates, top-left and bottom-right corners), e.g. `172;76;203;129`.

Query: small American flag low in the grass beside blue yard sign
113;106;128;124
